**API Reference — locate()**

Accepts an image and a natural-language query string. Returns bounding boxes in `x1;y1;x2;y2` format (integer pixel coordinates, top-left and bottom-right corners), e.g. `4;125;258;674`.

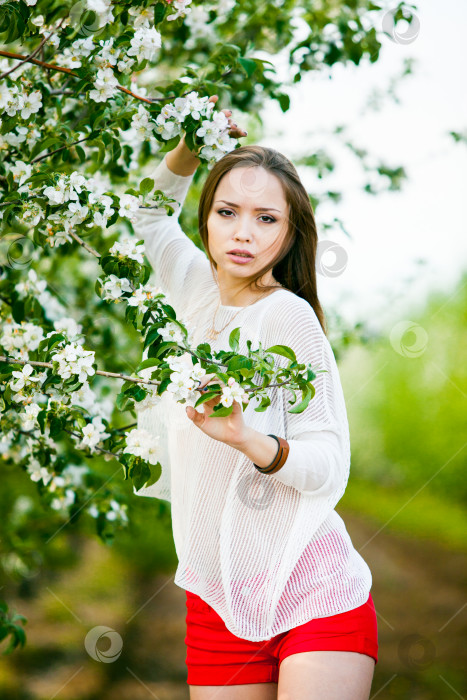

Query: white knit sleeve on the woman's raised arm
133;156;211;306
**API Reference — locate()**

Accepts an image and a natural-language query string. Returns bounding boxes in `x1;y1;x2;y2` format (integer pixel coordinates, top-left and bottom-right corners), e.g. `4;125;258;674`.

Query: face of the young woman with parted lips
207;166;289;288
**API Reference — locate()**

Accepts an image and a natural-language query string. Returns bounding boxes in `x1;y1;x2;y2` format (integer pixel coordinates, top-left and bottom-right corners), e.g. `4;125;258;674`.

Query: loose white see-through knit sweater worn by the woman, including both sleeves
134;153;372;641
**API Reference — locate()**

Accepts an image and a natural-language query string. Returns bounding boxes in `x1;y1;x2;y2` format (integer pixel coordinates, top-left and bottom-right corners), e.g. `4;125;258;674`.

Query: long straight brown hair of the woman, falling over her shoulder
198;145;327;334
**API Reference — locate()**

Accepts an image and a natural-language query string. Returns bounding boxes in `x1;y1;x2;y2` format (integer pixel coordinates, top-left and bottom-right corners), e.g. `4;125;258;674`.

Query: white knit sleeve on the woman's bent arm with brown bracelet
264;298;350;502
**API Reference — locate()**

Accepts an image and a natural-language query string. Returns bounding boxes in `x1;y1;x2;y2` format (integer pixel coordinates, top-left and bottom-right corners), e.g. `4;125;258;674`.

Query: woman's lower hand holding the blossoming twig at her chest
186;374;249;448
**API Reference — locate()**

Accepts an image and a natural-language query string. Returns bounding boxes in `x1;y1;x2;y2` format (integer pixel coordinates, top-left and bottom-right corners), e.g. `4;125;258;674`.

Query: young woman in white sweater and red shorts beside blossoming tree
134;96;378;700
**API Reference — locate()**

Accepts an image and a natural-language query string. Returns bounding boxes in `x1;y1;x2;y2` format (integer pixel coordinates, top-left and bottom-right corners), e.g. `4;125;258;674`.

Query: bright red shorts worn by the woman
185;591;378;685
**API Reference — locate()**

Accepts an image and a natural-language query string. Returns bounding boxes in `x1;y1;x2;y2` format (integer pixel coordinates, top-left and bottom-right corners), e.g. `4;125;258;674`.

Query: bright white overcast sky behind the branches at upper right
258;0;467;328
